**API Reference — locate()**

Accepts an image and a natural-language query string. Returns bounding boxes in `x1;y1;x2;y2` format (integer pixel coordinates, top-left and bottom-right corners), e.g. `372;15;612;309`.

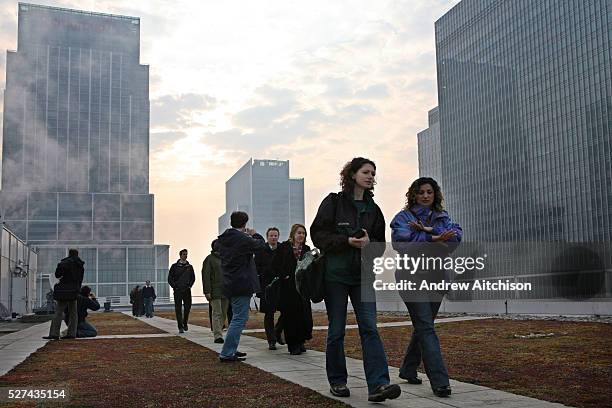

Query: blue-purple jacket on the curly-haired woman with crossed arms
391;205;463;242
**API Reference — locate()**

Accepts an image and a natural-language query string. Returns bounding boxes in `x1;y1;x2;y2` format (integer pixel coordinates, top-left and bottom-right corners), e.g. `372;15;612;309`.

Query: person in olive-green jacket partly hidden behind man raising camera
202;240;229;343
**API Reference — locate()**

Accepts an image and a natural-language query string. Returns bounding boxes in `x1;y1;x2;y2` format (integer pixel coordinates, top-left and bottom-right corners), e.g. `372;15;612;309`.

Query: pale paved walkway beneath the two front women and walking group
126;313;563;408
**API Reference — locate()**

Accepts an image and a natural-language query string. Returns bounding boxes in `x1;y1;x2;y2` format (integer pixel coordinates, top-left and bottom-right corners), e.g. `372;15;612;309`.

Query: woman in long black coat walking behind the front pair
272;224;312;355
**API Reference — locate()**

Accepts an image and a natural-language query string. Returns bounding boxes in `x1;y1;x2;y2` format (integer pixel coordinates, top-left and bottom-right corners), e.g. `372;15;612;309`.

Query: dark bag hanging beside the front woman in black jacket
295;248;325;303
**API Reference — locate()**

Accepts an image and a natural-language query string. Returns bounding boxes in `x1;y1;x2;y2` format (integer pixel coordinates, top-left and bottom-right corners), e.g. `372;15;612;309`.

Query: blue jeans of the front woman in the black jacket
325;282;390;394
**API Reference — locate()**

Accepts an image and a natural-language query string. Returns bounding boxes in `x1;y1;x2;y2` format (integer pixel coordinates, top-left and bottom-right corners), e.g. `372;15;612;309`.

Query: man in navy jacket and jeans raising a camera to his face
217;211;265;362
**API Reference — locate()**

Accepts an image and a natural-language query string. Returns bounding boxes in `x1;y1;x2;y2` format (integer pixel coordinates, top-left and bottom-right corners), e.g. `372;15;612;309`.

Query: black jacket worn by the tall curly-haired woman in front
310;192;386;284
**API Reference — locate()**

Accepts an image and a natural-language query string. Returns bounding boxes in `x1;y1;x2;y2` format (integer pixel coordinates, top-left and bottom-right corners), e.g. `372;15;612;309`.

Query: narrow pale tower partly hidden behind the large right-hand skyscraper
417;106;442;183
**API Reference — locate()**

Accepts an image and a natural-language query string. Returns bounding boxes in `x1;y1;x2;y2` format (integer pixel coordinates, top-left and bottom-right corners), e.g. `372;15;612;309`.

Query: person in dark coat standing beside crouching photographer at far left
43;248;85;340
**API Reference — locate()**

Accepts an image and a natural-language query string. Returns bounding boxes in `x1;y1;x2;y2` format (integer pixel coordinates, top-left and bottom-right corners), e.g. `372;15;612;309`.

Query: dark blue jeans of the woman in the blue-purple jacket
400;302;450;388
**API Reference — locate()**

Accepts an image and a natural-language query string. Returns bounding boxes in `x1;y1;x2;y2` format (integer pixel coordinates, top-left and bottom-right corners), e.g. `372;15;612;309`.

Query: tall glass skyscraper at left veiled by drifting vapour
1;3;168;300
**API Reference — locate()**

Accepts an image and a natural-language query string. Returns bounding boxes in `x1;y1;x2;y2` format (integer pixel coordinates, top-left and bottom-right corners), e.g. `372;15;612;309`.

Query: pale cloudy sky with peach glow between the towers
0;0;458;294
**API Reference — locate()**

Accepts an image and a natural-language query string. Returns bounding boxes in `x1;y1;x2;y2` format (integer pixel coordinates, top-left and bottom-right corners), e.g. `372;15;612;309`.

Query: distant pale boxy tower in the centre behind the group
219;159;304;239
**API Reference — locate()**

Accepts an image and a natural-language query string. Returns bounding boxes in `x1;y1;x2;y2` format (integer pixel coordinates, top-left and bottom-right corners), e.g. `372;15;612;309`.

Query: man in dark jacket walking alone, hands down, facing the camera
168;249;195;333
